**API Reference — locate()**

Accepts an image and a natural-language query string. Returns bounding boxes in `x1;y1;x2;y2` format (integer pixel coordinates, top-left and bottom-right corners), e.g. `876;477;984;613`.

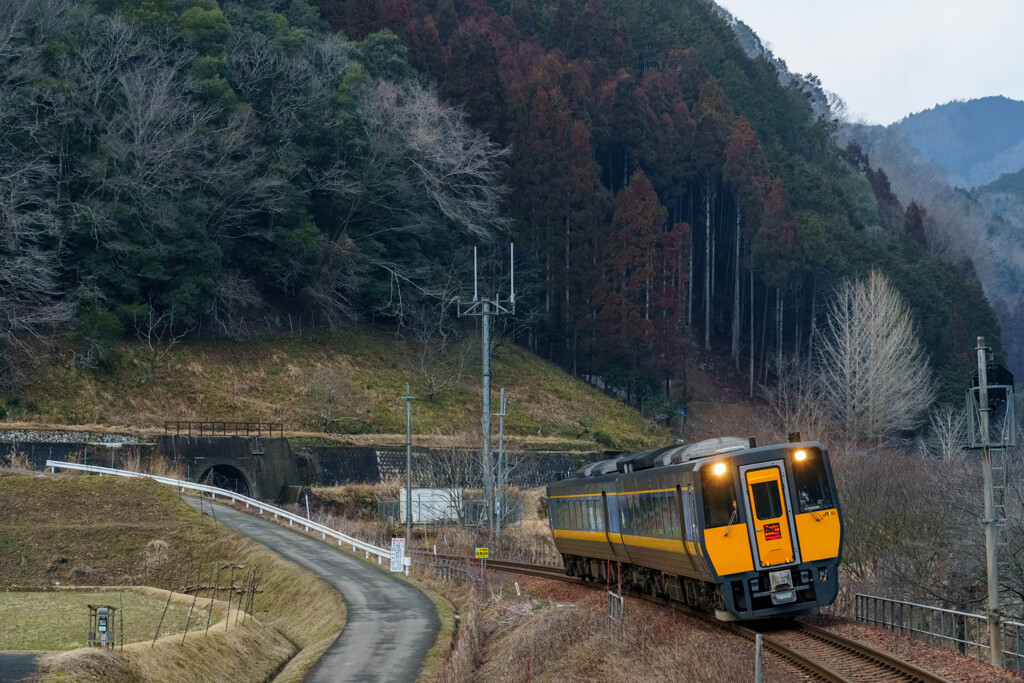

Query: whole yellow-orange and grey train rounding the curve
547;435;843;621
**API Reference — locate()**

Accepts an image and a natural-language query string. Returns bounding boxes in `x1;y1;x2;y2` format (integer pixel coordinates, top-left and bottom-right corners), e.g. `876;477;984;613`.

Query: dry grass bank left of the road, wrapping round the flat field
0;475;345;683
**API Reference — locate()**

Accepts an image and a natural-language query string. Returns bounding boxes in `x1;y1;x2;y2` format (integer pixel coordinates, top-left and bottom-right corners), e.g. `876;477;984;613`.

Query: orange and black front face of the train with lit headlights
694;443;843;618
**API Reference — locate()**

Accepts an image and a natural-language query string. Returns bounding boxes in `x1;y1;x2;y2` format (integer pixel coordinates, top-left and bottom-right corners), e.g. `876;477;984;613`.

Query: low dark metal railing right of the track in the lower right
854;593;1024;671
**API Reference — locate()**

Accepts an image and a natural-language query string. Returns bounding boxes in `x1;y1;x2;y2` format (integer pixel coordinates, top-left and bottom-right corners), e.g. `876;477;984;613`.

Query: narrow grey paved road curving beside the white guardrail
188;499;440;683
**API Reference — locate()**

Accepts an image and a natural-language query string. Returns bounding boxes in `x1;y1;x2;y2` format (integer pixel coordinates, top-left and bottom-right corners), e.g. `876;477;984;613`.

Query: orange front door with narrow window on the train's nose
740;460;800;568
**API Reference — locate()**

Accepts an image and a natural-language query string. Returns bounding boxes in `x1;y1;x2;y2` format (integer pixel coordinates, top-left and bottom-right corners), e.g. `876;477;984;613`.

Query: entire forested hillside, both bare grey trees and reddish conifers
0;0;998;417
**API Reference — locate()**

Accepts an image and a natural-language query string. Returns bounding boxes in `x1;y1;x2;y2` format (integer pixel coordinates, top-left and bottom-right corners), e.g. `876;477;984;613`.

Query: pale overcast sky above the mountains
718;0;1024;125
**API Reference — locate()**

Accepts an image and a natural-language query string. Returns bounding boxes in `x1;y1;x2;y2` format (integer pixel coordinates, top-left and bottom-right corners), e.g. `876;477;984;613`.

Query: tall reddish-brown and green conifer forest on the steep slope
321;0;998;403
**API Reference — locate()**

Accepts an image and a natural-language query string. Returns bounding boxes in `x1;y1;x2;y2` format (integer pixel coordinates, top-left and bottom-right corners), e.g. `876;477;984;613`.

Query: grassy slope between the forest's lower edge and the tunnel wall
0;331;671;451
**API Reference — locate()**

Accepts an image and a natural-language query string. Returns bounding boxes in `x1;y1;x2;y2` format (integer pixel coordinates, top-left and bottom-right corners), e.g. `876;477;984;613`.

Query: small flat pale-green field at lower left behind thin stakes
0;591;209;650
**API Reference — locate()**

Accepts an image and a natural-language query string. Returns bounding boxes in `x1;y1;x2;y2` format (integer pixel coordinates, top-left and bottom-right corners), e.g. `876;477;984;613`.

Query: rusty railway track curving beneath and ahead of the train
422;553;948;683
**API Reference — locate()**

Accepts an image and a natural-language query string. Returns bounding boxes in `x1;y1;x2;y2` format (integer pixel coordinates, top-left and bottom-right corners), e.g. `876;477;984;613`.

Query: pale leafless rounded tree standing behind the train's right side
819;271;935;446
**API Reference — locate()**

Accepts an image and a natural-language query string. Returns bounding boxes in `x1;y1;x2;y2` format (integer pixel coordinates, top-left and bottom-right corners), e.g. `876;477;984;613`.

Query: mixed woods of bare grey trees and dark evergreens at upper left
0;0;506;383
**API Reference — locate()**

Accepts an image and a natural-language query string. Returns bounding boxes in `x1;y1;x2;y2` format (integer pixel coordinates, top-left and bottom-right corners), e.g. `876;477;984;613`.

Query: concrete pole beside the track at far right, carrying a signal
977;337;1002;668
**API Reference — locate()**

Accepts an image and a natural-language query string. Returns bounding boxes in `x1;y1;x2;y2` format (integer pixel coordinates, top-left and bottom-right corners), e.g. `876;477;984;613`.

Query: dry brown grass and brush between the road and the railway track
456;577;799;683
